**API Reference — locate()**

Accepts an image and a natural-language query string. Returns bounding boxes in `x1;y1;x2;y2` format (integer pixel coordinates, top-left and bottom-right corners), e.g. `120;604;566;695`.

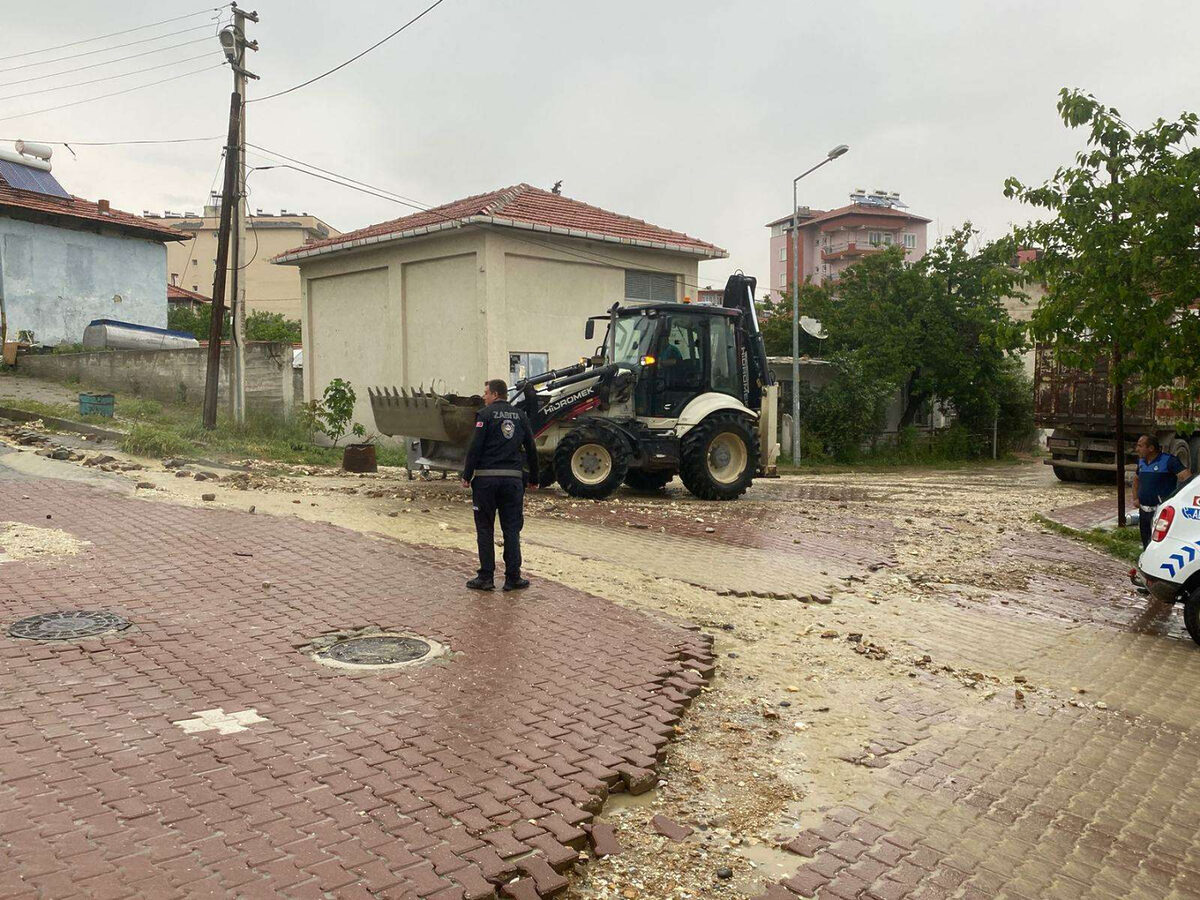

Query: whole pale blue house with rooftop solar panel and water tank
0;148;190;344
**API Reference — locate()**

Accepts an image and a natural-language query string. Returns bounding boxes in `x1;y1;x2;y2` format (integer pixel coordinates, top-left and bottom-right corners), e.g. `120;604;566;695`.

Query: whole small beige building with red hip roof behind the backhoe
274;184;727;426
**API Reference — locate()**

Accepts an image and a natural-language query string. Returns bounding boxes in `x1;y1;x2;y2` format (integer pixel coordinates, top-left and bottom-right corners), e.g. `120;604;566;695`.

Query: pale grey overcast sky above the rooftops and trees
0;0;1200;292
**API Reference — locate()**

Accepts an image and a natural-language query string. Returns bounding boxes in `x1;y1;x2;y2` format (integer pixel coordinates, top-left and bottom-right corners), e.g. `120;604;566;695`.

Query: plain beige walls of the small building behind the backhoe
291;228;697;430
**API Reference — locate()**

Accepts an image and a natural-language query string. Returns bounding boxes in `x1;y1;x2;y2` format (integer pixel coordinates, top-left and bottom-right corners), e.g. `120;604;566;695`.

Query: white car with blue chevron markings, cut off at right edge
1138;479;1200;643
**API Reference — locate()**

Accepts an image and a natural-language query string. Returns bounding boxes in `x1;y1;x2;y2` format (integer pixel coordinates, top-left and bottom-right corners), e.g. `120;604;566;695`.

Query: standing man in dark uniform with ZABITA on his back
462;378;538;590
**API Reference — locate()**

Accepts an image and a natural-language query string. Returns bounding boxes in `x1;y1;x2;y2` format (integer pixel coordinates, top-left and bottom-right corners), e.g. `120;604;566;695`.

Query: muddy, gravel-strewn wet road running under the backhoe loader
0;432;1200;900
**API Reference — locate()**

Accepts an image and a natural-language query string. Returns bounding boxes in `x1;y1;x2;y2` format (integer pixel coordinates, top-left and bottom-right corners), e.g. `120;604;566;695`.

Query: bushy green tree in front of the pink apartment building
810;230;1022;428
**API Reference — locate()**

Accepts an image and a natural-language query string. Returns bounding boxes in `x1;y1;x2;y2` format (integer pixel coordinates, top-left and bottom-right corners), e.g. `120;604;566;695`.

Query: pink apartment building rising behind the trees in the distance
767;191;929;293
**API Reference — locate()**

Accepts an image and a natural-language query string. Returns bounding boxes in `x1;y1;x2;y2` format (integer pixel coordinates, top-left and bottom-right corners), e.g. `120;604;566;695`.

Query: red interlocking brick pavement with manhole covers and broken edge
0;481;713;900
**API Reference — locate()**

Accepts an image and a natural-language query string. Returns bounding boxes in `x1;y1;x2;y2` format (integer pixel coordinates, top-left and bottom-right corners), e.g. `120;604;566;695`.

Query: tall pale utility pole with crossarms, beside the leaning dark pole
221;4;258;425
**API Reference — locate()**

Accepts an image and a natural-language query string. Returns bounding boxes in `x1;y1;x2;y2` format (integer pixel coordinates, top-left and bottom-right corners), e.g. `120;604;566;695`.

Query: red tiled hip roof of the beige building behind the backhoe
275;184;727;262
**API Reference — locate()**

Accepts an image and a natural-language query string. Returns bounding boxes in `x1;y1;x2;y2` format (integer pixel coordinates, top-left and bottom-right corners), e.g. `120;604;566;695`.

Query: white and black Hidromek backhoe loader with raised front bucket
370;275;778;500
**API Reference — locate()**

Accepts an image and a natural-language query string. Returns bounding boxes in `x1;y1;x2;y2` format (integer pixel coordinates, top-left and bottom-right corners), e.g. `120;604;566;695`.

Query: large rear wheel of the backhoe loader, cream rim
679;412;758;500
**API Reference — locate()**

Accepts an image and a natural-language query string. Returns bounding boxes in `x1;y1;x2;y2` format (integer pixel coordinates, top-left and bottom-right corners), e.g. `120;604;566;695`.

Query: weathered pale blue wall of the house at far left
0;216;167;344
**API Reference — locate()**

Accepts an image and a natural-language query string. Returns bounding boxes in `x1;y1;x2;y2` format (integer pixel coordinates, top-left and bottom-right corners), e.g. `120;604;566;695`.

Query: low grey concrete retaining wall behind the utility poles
19;342;295;414
